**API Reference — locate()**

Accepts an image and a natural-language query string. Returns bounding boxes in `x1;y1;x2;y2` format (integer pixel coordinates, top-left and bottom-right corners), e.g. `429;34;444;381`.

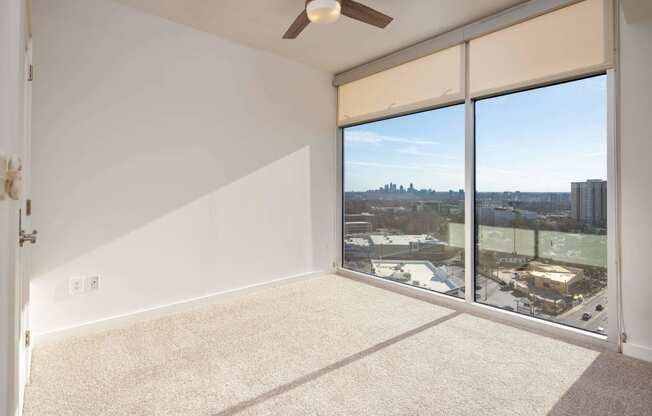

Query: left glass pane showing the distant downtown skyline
343;105;464;297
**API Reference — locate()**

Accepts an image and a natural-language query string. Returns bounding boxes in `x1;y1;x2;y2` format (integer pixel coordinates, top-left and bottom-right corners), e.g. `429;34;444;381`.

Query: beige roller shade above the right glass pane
469;0;613;97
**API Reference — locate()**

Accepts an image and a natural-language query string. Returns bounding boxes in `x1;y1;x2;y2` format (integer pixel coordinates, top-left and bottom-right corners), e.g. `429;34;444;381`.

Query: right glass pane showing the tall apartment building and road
475;75;607;334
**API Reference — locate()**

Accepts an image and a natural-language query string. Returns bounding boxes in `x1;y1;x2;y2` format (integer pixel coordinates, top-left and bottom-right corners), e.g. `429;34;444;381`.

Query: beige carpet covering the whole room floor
25;276;652;416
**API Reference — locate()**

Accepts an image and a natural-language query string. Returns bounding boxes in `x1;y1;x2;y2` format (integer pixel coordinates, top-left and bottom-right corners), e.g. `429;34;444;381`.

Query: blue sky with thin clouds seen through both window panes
344;76;607;192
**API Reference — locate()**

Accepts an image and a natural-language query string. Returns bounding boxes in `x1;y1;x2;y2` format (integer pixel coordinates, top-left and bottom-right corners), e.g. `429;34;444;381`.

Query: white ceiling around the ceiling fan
115;0;523;73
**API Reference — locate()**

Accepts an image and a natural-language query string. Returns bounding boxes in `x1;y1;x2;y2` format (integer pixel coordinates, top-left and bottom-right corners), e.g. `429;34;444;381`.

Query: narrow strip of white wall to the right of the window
620;0;652;361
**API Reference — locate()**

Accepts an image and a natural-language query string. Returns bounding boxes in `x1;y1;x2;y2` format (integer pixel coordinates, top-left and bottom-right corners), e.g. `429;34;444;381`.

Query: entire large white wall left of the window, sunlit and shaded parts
31;0;336;333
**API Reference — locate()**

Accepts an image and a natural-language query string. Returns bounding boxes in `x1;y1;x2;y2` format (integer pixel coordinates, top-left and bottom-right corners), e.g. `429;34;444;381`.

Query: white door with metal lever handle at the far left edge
0;0;31;416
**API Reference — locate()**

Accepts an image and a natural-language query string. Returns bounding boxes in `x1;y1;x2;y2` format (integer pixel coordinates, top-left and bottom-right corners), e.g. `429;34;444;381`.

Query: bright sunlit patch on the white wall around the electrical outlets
31;147;336;333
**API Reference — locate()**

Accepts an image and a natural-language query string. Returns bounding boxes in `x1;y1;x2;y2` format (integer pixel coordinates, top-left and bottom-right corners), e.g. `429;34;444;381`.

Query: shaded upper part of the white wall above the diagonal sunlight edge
32;0;335;282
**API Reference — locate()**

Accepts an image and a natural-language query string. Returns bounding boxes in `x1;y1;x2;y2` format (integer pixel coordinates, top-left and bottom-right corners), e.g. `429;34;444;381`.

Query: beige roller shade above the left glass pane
338;45;464;126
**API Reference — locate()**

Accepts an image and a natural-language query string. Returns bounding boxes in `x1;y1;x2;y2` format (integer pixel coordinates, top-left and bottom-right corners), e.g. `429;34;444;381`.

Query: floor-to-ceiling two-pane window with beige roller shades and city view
335;0;619;343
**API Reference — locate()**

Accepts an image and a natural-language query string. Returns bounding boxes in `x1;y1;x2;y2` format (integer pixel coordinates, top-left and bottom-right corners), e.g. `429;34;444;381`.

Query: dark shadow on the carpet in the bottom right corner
548;352;652;416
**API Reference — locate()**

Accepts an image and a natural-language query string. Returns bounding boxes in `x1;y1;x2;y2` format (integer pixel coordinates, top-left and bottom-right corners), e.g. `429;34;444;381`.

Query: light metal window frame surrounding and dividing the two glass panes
333;67;622;351
